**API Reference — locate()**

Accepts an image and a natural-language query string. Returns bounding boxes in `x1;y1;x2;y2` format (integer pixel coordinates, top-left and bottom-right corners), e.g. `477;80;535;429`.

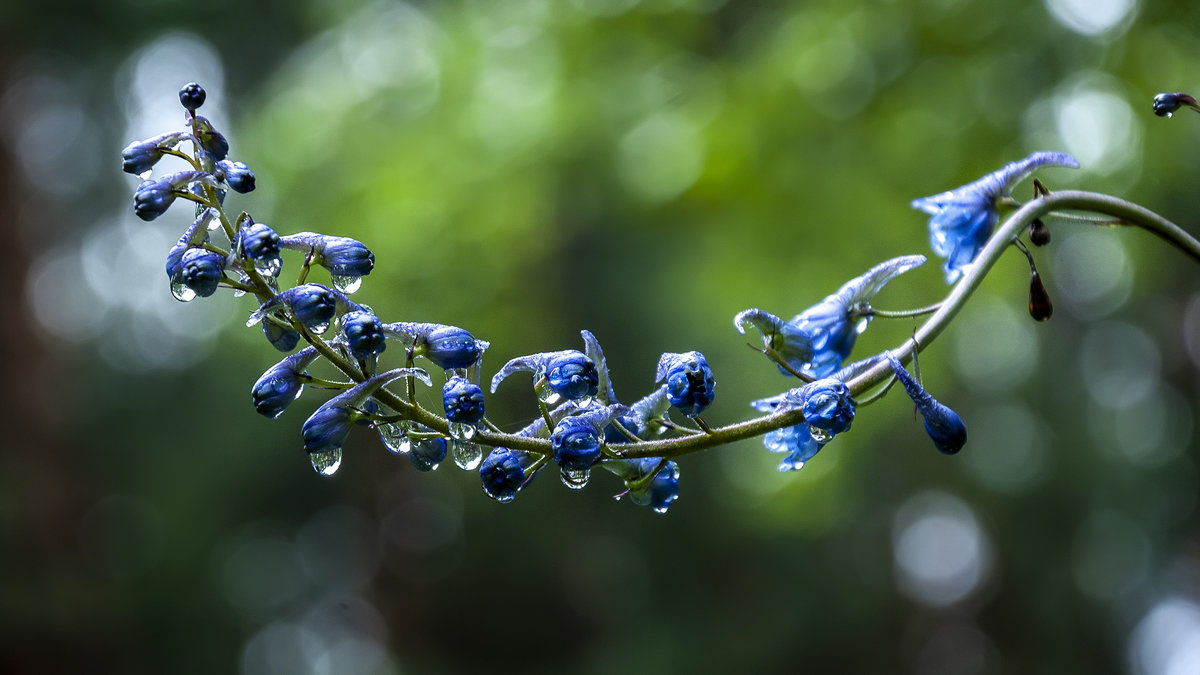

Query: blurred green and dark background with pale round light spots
0;0;1200;675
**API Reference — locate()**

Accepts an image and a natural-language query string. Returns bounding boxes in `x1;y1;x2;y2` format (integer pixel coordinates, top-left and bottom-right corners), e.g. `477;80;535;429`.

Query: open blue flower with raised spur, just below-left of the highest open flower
733;256;925;377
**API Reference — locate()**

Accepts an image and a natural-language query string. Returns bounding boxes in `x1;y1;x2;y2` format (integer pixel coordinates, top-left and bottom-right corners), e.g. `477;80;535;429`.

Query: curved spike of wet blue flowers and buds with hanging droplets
121;83;1200;513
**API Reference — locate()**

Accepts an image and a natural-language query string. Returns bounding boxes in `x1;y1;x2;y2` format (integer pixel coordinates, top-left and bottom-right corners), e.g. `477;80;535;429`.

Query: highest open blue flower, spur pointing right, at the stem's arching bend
912;153;1079;283
